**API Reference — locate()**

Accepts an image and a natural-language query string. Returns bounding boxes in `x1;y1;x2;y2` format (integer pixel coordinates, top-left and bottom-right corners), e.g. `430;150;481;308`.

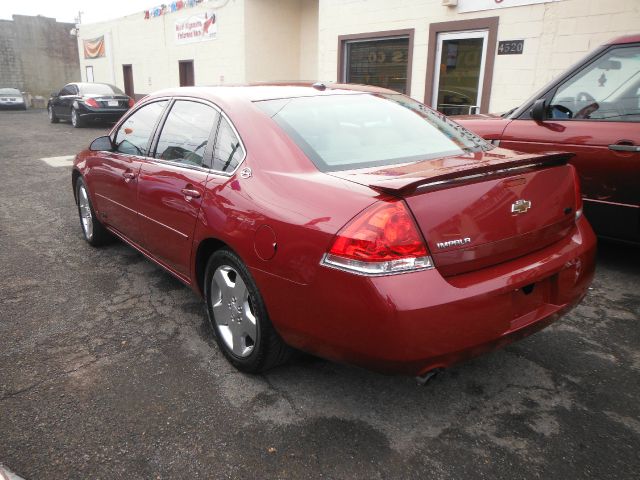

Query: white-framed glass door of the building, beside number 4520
431;30;489;115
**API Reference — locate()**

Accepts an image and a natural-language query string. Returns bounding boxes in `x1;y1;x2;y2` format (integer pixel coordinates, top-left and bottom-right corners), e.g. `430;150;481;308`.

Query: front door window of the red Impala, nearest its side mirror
114;100;167;157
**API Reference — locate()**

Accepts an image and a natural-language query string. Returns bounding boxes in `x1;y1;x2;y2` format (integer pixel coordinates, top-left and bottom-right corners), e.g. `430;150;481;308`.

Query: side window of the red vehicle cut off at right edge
549;47;640;122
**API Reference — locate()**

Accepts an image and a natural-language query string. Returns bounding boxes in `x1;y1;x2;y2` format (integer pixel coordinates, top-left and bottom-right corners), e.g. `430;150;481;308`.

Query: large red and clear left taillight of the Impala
324;200;433;274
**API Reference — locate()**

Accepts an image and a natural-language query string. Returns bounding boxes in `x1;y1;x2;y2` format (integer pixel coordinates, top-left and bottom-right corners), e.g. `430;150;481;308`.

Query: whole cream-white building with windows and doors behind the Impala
78;0;640;113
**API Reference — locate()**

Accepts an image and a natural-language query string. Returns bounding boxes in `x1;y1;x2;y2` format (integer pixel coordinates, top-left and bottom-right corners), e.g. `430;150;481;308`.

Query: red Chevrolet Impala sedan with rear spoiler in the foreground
73;84;595;375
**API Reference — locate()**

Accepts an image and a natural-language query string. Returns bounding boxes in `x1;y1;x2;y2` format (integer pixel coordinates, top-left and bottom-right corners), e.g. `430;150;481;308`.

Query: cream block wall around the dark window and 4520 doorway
318;0;640;112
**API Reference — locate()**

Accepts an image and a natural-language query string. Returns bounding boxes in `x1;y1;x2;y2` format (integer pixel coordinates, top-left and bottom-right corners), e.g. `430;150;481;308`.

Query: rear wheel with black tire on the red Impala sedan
204;249;292;373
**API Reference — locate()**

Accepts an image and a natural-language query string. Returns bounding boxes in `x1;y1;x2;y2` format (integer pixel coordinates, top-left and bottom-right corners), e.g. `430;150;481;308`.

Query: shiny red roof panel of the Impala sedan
148;82;398;102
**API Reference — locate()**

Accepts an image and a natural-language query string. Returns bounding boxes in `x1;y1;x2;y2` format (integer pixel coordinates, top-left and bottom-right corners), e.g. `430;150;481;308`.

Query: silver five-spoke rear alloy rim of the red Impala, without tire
211;265;258;358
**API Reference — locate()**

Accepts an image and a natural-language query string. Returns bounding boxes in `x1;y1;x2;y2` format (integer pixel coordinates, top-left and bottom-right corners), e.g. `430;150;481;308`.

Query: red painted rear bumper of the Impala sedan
252;217;596;375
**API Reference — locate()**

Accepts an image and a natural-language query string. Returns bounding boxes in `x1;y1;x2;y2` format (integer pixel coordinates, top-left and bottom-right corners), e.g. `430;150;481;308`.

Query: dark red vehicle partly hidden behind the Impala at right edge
454;35;640;244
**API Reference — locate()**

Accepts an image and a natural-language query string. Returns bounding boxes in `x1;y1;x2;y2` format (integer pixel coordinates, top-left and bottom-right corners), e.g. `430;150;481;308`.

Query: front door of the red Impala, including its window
87;100;169;244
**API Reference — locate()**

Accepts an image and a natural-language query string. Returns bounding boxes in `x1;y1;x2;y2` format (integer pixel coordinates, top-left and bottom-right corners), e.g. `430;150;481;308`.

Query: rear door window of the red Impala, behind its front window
155;100;220;166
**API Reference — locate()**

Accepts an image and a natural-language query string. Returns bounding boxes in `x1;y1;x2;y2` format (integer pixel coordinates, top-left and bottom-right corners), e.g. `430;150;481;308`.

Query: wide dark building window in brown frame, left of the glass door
343;37;409;93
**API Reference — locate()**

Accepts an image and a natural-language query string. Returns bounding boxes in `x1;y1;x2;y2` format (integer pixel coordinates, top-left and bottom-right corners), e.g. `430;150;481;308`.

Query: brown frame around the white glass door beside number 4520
424;17;500;113
